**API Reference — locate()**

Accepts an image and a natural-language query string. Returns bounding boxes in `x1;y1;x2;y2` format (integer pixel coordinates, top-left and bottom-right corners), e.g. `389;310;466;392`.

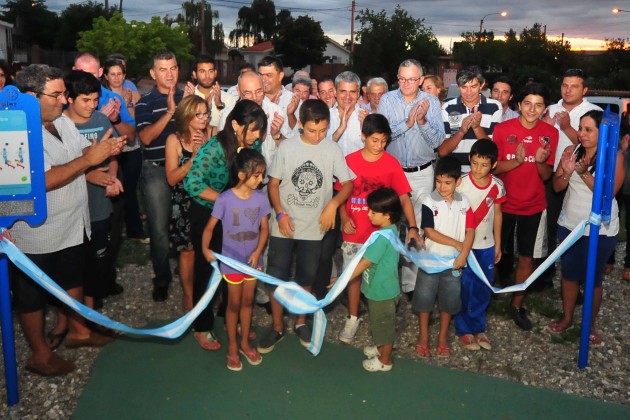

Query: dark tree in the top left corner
1;0;59;48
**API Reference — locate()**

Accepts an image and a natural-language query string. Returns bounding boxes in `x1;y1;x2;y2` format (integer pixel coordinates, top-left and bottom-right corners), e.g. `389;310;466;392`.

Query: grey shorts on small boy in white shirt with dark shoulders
411;270;462;315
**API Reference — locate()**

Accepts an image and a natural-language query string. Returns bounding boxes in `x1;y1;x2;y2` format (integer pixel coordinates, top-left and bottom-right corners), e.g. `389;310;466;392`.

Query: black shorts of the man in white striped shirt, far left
12;244;87;313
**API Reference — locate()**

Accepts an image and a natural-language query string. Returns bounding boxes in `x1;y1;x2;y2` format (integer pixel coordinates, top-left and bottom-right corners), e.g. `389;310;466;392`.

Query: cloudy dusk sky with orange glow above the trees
46;0;630;50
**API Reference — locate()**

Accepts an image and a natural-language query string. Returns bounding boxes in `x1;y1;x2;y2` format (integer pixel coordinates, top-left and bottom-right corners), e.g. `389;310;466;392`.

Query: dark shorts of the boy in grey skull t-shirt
267;236;322;289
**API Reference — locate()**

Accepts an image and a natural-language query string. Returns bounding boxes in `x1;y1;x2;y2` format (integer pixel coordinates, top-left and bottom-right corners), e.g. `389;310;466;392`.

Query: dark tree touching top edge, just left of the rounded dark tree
230;0;290;47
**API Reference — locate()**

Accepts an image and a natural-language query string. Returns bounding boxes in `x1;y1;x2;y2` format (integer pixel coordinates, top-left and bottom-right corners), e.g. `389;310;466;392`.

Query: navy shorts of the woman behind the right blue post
558;226;617;287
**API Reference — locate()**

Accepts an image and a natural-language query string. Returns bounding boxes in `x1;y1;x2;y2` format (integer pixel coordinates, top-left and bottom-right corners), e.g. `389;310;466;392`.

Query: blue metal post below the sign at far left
0;248;19;406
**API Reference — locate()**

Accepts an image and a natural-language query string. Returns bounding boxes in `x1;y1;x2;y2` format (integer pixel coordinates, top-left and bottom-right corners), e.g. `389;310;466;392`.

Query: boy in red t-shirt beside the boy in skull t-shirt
339;114;421;343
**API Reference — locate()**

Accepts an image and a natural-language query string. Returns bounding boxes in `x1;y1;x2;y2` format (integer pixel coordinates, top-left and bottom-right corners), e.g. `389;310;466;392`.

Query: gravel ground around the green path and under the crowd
0;243;630;419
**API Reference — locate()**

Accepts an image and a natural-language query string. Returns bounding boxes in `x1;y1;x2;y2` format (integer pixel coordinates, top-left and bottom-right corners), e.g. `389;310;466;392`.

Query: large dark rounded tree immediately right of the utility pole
352;6;446;81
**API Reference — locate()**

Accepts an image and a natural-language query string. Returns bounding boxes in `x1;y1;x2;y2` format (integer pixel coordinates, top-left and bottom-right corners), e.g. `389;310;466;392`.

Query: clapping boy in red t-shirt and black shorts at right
493;83;558;330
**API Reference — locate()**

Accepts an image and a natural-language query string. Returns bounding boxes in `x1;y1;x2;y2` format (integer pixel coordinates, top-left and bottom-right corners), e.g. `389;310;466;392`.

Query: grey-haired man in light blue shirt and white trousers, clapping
378;59;444;294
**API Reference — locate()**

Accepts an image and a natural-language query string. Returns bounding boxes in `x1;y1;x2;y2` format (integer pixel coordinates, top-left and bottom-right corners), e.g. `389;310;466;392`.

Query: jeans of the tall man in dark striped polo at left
140;161;172;287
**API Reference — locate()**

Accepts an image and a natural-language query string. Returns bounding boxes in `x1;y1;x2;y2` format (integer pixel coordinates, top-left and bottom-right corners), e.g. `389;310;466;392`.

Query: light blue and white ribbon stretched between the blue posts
0;220;588;356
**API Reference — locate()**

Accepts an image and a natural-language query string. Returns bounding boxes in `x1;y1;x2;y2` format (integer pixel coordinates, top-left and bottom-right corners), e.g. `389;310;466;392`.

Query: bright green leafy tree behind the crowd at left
77;12;193;77
